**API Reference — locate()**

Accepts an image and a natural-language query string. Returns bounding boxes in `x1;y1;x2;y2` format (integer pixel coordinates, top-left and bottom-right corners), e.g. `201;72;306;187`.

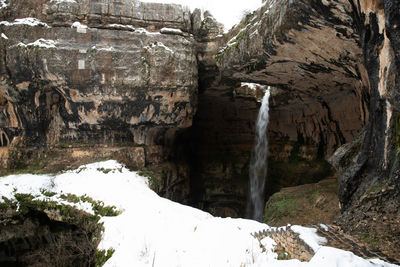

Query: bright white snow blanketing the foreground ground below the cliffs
0;161;396;267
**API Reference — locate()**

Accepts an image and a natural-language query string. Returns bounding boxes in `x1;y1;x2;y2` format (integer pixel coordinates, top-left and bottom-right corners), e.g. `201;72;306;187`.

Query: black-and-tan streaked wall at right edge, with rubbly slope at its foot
332;1;400;258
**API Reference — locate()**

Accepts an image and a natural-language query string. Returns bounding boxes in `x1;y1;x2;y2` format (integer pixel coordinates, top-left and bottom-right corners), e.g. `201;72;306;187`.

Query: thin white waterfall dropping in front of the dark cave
247;87;270;222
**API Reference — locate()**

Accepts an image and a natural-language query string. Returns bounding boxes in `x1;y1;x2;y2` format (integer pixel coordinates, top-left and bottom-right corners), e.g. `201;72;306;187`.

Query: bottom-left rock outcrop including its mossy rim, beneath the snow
0;199;102;266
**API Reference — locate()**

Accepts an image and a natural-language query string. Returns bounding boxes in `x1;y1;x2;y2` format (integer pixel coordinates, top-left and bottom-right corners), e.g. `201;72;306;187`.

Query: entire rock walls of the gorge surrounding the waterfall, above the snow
0;0;400;264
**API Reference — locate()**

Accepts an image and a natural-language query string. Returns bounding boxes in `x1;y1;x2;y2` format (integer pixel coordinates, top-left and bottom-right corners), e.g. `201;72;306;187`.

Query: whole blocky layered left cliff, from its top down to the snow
0;0;198;201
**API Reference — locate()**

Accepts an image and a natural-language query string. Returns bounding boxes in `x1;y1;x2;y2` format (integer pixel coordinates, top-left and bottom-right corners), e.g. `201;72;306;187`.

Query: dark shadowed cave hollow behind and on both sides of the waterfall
184;77;367;220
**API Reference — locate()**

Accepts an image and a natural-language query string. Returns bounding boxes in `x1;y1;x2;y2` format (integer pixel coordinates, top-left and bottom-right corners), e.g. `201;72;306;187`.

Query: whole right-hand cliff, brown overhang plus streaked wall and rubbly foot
216;0;400;260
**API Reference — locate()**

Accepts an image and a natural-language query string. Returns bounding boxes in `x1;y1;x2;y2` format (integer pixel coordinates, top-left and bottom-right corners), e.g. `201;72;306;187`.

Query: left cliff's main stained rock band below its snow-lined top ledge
1;1;197;149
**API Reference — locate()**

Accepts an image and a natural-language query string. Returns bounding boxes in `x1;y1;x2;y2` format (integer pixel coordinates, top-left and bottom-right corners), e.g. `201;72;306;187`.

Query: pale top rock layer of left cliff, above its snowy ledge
1;0;192;33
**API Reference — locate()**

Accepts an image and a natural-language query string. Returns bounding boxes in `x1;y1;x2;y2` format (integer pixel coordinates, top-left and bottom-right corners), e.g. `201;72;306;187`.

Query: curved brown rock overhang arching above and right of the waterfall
216;0;368;156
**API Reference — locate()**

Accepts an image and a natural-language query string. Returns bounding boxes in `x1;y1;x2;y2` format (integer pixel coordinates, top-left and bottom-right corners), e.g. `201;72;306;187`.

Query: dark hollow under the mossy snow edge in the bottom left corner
0;210;98;266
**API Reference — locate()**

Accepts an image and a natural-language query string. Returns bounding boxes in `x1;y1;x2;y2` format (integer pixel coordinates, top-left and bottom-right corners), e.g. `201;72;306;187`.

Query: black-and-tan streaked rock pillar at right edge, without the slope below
334;1;400;208
